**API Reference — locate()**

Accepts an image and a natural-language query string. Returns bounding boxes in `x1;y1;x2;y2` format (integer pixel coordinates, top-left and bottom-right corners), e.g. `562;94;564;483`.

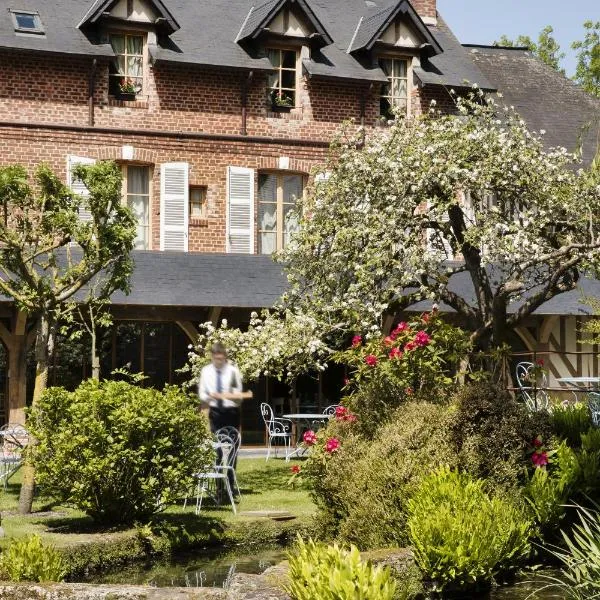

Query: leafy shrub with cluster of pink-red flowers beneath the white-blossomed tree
334;311;470;434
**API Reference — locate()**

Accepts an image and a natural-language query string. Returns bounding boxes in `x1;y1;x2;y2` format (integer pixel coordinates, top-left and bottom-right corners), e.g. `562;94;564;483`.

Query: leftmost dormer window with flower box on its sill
109;33;145;96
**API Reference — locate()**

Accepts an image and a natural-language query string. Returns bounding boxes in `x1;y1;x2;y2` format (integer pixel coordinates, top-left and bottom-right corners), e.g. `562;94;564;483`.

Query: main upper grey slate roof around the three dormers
0;0;494;87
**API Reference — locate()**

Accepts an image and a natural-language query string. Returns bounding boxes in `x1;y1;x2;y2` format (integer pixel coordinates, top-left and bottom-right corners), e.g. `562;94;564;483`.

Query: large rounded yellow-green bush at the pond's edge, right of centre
408;469;532;590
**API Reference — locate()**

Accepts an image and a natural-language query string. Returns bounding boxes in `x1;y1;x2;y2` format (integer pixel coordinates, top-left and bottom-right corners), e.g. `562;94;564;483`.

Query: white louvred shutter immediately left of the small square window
160;163;190;252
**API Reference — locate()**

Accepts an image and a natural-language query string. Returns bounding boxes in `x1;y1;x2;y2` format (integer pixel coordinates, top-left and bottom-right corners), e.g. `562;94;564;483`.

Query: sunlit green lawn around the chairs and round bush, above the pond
0;458;315;549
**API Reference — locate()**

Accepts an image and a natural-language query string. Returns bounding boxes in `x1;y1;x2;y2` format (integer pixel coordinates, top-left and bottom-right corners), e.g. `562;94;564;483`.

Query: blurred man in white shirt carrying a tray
198;342;244;433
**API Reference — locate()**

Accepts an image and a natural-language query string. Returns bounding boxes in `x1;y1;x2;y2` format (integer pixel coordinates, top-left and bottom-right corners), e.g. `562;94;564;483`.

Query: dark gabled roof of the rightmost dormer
348;0;442;54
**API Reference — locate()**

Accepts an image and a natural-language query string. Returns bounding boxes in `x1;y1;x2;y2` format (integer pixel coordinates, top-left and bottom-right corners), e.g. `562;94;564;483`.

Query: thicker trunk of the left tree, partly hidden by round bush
19;315;54;515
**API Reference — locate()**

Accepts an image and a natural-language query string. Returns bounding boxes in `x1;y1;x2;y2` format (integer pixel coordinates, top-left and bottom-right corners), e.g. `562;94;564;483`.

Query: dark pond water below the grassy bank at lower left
87;547;286;587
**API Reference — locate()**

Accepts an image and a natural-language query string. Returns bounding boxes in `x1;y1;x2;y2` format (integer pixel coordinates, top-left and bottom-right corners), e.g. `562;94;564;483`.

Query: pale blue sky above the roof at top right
437;0;600;75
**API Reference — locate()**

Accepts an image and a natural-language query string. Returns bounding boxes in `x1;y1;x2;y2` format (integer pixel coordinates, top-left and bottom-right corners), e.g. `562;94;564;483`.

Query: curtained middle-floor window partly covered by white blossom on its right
258;173;304;254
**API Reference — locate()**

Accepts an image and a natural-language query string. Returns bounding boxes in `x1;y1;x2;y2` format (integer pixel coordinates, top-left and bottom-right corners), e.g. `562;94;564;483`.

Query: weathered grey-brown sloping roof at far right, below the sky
465;45;600;163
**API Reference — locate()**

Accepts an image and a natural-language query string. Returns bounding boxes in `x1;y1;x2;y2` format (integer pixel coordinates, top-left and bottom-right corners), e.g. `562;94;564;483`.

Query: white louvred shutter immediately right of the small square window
227;167;254;254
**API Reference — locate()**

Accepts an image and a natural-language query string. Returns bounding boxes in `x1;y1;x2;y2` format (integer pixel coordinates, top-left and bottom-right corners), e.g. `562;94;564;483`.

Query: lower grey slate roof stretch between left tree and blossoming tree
112;251;287;308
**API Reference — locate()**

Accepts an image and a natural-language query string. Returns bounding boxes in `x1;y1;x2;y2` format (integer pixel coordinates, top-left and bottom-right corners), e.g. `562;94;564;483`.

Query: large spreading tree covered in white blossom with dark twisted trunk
281;91;600;348
